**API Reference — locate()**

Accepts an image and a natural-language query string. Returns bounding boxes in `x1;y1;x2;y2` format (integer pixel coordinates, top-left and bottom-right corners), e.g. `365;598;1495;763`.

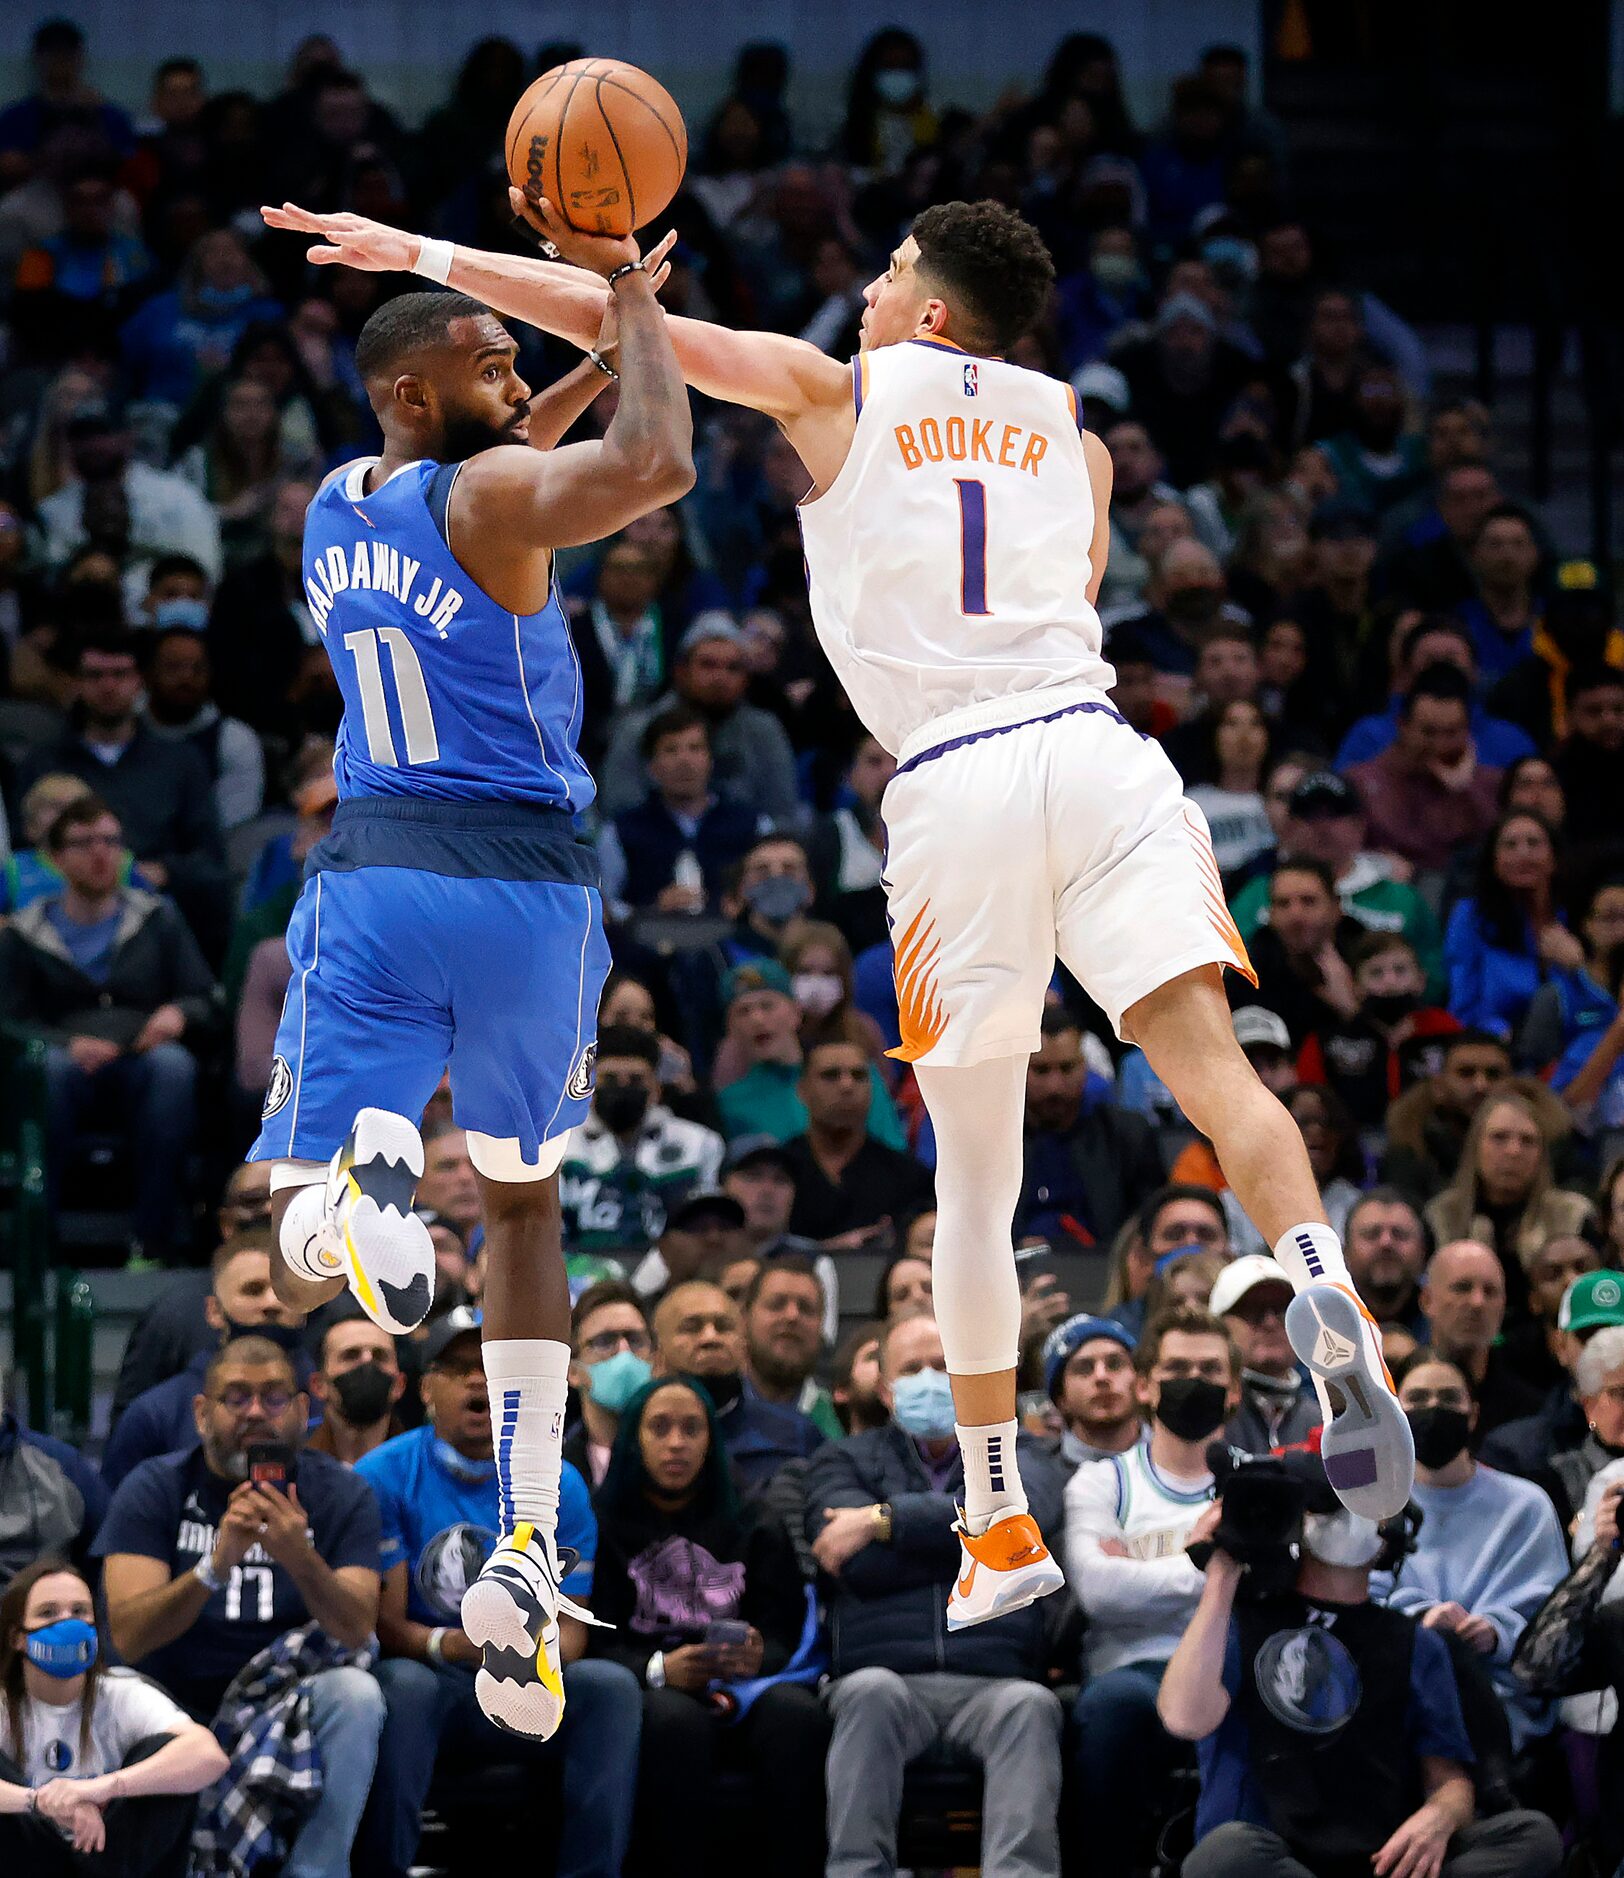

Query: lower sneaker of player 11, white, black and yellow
462;1521;608;1741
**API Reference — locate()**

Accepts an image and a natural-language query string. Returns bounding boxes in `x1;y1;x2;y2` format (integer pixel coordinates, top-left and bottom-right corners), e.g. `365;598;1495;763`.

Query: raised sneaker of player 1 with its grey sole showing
1286;1285;1416;1521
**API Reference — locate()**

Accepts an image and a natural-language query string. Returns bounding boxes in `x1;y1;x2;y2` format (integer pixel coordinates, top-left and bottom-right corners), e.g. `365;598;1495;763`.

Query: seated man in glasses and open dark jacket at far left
0;796;218;1260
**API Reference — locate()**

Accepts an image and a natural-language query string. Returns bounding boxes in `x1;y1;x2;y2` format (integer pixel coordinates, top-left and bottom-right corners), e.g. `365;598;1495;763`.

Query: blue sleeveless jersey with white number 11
304;458;593;813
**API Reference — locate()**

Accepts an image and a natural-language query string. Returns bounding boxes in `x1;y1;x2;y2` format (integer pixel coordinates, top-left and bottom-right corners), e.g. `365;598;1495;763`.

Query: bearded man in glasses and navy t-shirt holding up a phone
96;1337;383;1878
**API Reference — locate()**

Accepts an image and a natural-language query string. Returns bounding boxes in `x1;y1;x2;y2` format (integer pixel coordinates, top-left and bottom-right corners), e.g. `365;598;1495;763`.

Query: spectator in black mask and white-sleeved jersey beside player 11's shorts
559;1025;723;1255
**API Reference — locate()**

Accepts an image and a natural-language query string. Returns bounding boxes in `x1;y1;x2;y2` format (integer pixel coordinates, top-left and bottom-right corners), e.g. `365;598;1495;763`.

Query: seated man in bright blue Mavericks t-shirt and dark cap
355;1307;642;1878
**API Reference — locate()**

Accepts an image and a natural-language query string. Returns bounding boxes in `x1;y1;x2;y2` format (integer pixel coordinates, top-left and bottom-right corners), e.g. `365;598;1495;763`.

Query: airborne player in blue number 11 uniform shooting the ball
253;198;693;1737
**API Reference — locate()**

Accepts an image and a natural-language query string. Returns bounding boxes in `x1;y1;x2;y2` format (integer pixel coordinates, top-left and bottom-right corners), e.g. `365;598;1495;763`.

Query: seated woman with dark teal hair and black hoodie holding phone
590;1377;828;1878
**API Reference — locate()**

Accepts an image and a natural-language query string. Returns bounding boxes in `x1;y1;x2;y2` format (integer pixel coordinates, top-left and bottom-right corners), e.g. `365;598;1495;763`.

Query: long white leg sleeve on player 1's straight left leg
916;1057;1027;1377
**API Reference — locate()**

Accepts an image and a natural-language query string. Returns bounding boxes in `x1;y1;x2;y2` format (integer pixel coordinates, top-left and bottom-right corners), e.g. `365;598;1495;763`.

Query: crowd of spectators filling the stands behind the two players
0;21;1624;1878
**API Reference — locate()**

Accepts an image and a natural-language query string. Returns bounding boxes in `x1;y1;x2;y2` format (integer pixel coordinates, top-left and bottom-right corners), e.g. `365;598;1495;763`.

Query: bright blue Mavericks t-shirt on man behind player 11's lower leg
355;1427;597;1624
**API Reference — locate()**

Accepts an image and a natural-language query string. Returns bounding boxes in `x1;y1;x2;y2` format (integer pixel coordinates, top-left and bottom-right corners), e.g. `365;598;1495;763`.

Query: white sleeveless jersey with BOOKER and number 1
800;338;1115;759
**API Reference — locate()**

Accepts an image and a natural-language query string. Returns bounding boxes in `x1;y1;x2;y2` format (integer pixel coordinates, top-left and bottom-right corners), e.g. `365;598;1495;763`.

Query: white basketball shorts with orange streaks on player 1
884;693;1258;1067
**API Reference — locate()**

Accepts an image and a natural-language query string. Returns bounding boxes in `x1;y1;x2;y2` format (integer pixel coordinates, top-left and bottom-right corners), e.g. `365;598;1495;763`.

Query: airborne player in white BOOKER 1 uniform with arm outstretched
266;192;1414;1626
